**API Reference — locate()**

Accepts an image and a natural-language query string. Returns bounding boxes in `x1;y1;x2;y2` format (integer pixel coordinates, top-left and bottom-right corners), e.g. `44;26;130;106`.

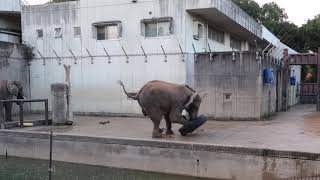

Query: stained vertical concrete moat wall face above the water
0;131;320;180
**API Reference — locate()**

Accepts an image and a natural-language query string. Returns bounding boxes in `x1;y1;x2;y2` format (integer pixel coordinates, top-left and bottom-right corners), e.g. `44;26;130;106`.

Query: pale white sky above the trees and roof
26;0;320;26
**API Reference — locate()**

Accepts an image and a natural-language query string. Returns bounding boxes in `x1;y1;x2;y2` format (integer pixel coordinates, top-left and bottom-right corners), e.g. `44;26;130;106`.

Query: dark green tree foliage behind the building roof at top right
233;0;320;52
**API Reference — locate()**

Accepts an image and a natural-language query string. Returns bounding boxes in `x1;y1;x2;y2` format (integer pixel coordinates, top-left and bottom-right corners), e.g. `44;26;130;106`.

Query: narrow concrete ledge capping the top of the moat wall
0;130;320;161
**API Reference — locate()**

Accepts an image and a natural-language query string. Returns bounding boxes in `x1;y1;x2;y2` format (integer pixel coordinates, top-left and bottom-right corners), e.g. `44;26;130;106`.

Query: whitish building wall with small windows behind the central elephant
22;0;255;114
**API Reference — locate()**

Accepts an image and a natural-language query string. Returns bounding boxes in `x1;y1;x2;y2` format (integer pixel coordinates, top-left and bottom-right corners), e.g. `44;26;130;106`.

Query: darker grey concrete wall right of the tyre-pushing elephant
194;52;282;120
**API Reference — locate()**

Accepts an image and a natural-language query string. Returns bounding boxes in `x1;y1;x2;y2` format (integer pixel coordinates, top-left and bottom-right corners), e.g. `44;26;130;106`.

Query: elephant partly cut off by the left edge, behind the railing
0;80;24;123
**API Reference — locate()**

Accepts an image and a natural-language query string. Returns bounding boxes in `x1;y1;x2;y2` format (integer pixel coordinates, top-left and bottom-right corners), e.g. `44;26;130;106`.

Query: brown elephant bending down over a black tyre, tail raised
119;80;201;138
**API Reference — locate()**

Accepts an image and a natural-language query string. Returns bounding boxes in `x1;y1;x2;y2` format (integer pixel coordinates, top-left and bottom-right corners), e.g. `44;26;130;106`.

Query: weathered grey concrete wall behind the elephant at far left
0;42;30;113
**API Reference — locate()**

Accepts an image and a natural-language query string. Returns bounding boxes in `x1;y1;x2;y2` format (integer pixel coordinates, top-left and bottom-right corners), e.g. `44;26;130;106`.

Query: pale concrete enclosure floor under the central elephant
17;105;320;153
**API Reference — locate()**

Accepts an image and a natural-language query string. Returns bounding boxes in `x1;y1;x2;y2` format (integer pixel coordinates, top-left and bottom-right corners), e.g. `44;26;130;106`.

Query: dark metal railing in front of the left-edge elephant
0;99;50;128
